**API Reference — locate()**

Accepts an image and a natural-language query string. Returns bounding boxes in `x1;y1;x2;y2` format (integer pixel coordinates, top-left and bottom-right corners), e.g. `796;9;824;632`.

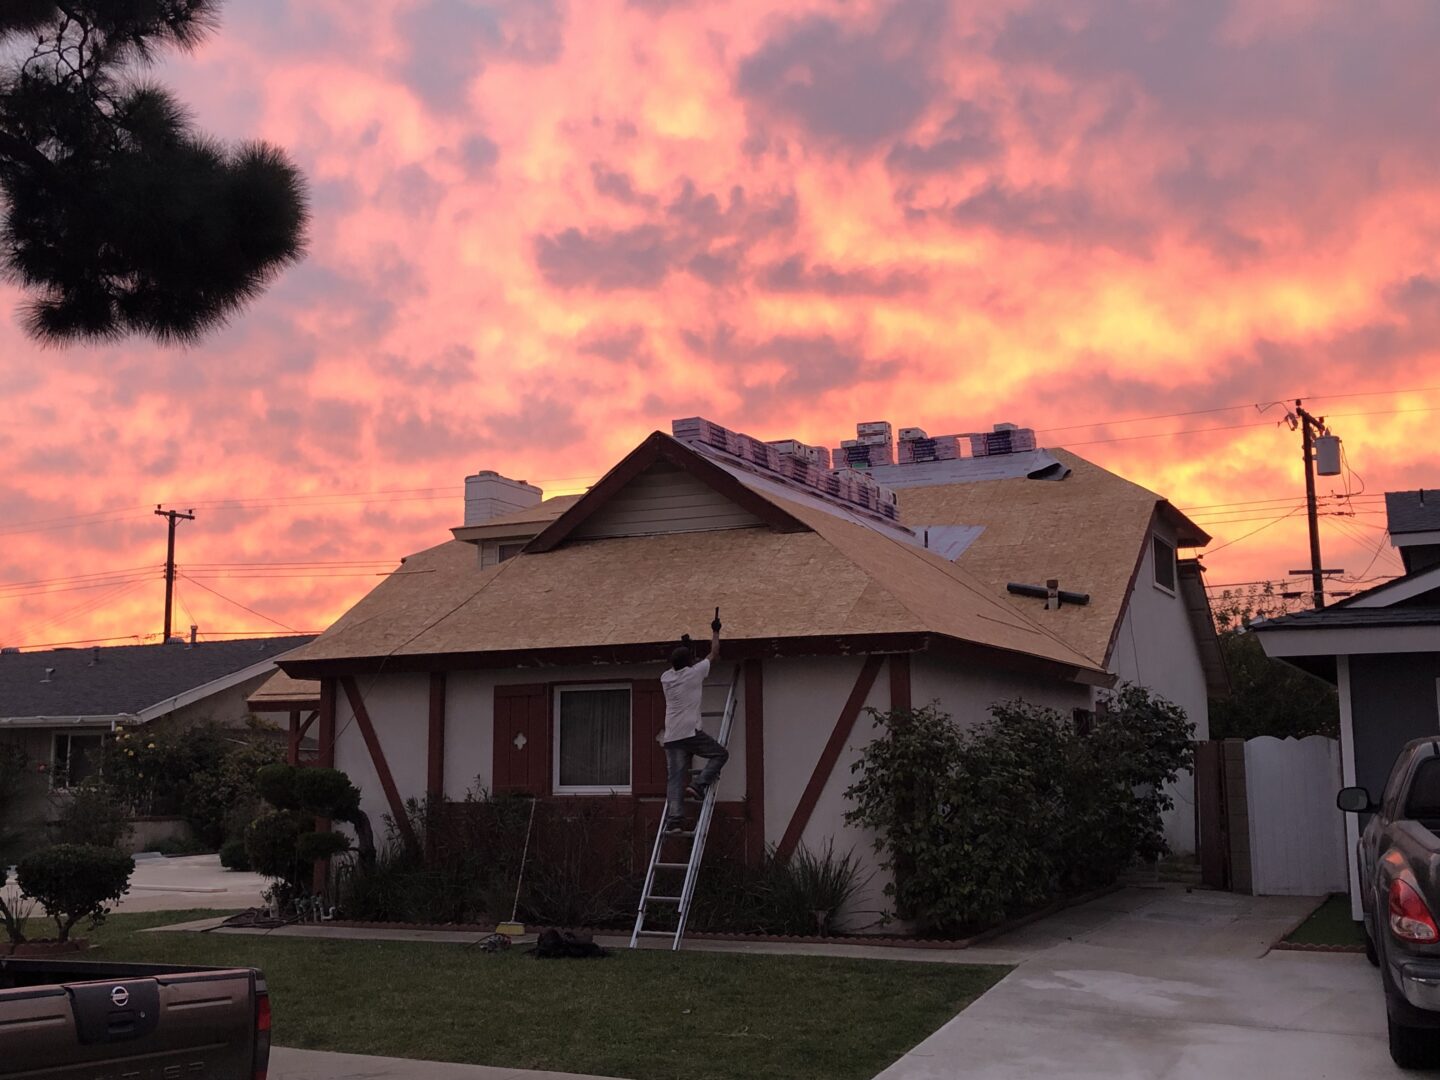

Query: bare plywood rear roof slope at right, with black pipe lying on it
899;449;1210;665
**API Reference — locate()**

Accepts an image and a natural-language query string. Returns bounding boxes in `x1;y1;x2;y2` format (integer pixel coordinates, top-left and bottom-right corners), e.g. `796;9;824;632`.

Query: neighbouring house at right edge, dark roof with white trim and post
1251;490;1440;919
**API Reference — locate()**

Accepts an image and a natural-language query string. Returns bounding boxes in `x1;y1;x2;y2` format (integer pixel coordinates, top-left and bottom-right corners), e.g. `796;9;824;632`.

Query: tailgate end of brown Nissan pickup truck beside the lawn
0;958;271;1080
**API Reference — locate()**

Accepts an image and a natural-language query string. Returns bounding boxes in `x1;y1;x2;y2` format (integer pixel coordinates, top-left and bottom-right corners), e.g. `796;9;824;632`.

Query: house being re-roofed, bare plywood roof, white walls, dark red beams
266;420;1214;927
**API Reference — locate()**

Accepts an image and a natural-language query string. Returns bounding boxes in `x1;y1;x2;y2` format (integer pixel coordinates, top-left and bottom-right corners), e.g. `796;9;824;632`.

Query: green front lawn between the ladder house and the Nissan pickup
91;912;1008;1080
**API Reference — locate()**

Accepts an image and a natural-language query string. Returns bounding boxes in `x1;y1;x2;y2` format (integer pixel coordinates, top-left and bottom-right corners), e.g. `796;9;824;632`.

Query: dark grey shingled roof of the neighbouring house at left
0;635;312;719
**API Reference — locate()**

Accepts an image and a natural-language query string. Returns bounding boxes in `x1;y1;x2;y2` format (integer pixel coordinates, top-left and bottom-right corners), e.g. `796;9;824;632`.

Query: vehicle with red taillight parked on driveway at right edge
1335;739;1440;1068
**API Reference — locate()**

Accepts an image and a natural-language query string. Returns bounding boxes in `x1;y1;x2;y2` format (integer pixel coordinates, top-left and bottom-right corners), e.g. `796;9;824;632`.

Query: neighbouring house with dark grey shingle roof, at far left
0;636;311;846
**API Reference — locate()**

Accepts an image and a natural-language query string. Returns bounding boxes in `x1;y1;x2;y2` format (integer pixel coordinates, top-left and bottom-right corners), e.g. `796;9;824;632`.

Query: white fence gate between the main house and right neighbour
1246;734;1346;896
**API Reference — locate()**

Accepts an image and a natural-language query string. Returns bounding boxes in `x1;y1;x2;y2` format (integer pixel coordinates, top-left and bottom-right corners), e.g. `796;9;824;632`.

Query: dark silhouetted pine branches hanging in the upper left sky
0;0;310;343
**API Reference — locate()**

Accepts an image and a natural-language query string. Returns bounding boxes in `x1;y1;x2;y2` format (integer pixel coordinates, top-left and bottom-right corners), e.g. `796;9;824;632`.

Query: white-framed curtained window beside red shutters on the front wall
554;685;631;792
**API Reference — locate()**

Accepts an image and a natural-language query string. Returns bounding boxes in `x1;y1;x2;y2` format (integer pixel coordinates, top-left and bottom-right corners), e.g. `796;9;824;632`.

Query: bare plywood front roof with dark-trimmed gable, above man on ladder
284;432;1107;681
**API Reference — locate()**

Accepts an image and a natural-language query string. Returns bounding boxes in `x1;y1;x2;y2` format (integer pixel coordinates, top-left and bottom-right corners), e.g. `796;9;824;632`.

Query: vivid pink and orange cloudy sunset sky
0;0;1440;645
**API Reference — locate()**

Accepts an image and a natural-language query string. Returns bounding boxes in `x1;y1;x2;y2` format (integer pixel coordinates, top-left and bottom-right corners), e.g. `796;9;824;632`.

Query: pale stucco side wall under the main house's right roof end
1110;523;1210;854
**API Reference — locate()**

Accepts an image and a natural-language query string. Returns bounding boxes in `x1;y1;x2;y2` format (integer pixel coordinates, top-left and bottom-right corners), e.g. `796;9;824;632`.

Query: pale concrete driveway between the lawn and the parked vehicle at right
877;887;1405;1080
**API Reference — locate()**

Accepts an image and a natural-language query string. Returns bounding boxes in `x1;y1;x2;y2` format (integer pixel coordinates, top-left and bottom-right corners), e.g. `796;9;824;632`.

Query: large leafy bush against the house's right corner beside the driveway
845;685;1192;933
